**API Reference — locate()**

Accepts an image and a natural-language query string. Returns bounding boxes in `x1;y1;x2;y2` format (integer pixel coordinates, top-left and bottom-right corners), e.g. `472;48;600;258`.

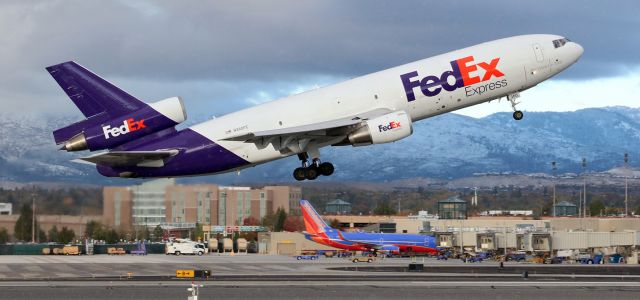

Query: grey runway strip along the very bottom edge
0;281;640;300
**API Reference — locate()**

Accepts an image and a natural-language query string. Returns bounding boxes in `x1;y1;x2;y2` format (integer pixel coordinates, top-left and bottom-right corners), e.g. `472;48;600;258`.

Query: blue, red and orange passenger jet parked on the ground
300;200;438;254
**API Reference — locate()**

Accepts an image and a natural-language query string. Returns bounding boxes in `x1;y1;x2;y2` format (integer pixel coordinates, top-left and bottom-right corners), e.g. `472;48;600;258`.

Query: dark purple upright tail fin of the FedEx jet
46;61;147;144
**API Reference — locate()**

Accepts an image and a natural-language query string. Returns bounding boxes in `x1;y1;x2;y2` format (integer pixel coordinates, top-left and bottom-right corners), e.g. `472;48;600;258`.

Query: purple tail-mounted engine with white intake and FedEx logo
63;97;187;151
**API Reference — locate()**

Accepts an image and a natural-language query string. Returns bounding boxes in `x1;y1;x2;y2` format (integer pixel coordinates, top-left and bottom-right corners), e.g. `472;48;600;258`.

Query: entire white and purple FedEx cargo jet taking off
46;34;583;180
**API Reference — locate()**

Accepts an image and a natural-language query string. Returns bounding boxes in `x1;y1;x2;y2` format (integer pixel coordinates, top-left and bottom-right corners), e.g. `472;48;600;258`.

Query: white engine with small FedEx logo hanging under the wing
347;111;413;146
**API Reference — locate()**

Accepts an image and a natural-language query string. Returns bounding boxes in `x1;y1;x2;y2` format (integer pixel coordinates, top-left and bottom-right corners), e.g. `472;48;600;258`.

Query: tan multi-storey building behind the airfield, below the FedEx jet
103;179;302;229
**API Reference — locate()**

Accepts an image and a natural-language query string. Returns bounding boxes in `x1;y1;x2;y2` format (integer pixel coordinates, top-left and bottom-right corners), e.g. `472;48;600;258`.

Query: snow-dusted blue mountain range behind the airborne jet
0;107;640;184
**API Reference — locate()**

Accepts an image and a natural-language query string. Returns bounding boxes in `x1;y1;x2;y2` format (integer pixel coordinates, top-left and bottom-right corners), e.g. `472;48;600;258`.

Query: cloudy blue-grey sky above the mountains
0;0;640;117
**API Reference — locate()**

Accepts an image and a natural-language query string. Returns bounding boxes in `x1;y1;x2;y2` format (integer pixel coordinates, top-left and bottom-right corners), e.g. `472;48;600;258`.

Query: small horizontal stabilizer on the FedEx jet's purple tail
79;150;178;168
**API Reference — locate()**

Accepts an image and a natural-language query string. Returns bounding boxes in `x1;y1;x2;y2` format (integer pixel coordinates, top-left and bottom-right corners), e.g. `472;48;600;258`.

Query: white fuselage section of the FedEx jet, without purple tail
191;35;583;169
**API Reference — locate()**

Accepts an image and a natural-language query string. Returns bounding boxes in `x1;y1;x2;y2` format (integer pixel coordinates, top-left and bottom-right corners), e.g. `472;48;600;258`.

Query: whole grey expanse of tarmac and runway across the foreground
0;255;640;300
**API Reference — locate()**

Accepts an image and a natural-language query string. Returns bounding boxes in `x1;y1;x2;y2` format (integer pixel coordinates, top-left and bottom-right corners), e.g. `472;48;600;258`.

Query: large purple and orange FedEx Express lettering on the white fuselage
400;56;507;102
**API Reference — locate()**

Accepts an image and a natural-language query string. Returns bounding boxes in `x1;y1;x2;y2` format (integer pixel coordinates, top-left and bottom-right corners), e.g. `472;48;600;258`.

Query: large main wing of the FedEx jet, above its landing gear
222;108;392;144
